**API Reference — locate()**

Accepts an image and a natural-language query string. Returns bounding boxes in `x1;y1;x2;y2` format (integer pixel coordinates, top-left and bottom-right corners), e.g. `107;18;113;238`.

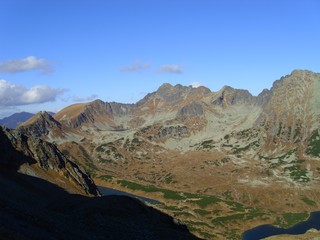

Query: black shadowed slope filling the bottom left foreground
0;126;197;240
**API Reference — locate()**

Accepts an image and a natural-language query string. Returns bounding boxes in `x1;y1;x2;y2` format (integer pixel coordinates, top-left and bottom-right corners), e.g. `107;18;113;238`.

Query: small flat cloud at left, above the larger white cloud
0;56;53;74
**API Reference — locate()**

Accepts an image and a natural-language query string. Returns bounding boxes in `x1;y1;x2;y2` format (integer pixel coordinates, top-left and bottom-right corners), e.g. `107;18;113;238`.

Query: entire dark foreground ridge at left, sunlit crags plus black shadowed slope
0;128;198;240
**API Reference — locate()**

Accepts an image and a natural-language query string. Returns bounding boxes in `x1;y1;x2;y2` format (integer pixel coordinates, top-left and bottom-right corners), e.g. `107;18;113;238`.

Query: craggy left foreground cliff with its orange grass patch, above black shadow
0;128;100;196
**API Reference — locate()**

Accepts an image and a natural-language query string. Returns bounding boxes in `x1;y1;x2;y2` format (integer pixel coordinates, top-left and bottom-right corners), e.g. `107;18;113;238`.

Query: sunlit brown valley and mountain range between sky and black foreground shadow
5;70;320;239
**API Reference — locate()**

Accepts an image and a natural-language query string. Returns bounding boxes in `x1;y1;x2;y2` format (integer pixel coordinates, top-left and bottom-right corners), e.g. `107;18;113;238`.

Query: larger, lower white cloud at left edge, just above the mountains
0;80;65;106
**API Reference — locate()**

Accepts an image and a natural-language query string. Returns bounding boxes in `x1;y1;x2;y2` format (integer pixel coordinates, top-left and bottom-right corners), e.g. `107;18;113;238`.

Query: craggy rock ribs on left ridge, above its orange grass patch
0;128;100;196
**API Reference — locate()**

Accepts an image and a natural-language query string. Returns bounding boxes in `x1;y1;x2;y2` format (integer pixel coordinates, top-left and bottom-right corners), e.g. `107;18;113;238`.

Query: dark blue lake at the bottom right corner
242;211;320;240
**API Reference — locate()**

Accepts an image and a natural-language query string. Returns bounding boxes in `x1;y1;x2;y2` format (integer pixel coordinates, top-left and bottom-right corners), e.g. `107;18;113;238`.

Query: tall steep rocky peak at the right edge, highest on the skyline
256;70;320;142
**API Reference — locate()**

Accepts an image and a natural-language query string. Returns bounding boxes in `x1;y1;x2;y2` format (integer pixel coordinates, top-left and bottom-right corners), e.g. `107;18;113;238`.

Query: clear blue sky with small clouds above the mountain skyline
0;0;320;118
